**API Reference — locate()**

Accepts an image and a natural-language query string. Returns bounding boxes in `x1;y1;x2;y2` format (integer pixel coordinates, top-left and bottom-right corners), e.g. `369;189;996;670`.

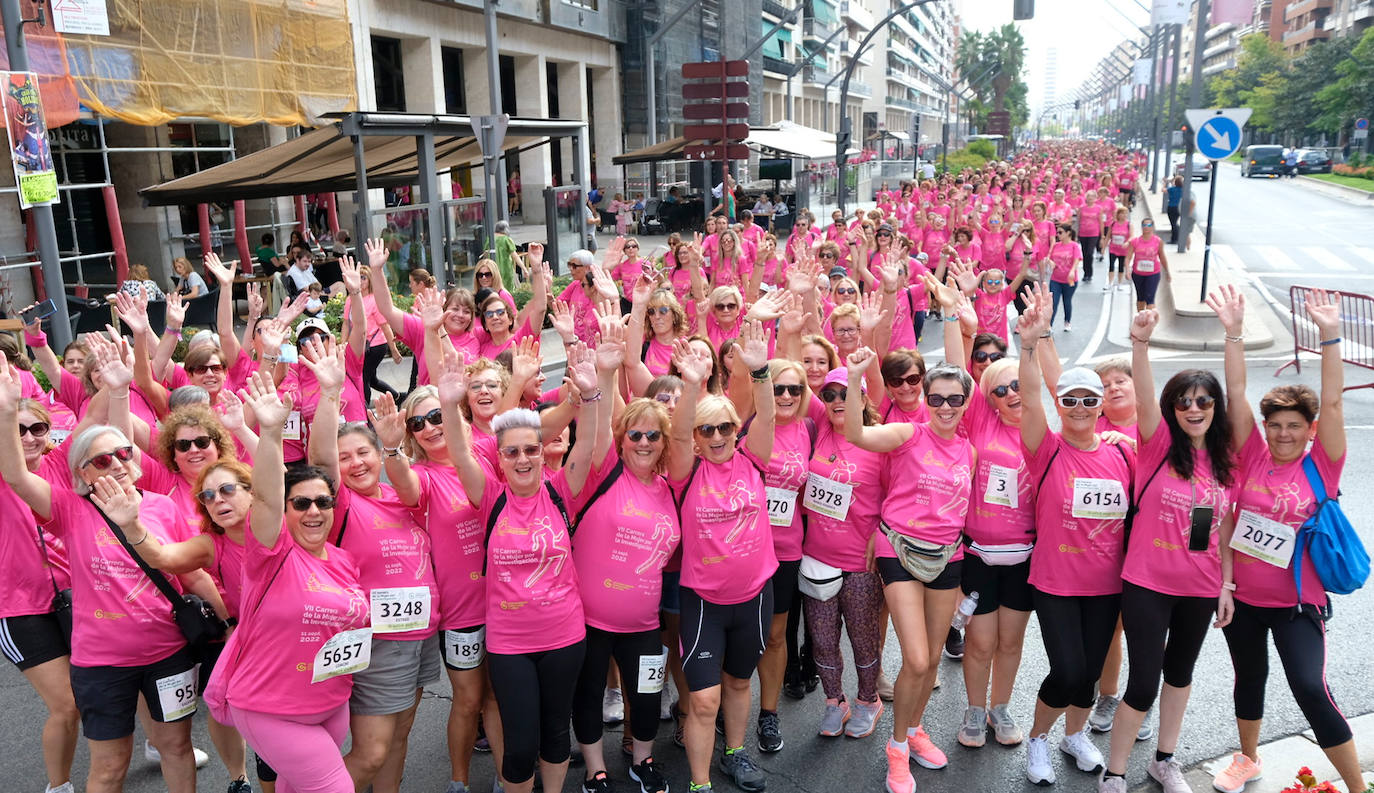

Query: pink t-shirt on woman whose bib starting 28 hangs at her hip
573;449;682;634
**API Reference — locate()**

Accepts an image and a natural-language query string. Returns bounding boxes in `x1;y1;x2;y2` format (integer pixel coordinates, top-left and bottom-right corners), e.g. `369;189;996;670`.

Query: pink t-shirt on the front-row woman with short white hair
481;470;587;654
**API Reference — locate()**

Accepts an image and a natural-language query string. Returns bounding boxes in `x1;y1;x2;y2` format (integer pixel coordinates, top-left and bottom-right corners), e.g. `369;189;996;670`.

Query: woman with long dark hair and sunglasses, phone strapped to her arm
1098;309;1235;793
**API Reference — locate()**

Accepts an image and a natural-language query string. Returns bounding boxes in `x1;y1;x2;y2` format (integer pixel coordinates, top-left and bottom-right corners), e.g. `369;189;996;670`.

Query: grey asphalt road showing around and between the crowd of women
10;174;1374;793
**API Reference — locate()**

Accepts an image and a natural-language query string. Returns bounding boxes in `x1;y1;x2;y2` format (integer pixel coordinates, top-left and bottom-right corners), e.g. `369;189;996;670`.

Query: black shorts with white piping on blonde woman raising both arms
679;583;772;691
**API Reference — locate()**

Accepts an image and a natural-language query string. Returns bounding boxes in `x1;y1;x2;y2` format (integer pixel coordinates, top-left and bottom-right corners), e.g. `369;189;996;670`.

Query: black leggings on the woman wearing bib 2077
1221;601;1351;749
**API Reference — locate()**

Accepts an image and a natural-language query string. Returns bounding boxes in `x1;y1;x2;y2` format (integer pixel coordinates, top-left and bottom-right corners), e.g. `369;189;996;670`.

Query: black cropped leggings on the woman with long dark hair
1121;581;1216;711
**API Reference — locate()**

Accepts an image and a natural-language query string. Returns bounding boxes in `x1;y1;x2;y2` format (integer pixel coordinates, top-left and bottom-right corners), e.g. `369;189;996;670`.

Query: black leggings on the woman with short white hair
486;642;585;785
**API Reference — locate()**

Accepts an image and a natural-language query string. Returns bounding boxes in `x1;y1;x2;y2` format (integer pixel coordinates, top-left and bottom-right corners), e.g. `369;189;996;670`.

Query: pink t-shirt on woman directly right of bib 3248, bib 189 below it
412;458;496;631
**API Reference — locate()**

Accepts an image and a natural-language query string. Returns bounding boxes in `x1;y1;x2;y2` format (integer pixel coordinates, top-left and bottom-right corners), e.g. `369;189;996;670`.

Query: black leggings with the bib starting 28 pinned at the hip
573;625;664;744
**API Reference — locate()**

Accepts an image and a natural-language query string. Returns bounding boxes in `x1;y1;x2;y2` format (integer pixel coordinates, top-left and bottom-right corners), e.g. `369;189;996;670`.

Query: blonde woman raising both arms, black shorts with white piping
668;322;778;790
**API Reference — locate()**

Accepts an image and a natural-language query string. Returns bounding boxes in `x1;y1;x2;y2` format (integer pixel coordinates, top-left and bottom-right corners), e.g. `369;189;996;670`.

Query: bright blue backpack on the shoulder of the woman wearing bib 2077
1293;455;1370;603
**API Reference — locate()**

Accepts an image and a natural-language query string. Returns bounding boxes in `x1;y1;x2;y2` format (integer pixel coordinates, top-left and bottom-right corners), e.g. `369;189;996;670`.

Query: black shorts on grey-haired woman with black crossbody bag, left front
71;647;195;741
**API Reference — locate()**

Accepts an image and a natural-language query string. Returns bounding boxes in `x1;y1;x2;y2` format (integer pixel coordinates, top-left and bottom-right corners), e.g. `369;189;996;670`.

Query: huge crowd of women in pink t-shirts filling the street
0;138;1362;793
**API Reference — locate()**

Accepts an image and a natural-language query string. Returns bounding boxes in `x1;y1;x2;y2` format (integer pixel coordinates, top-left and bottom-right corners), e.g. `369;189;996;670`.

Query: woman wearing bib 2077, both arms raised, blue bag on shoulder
1208;287;1364;793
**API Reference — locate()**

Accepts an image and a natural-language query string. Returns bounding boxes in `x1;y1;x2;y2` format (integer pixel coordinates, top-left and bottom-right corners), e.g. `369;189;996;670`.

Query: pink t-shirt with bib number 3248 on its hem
330;485;440;642
